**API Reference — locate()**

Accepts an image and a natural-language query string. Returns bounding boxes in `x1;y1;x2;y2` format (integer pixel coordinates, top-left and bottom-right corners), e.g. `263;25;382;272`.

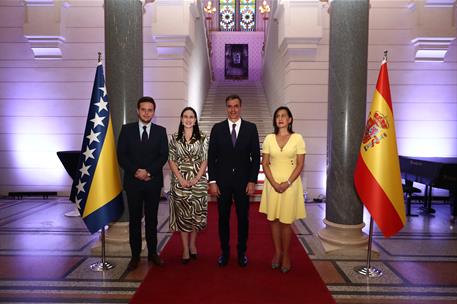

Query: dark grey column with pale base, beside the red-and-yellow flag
319;0;369;255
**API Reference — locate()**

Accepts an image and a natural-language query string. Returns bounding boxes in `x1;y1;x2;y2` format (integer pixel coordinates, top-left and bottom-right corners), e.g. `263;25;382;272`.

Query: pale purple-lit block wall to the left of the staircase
0;0;210;195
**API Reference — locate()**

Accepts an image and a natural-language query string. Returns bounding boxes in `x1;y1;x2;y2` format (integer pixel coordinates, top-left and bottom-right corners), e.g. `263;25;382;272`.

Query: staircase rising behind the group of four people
199;81;273;202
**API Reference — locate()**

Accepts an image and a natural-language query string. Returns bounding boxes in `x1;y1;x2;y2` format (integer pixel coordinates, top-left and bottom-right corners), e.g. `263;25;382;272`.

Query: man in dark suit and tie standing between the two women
208;95;260;267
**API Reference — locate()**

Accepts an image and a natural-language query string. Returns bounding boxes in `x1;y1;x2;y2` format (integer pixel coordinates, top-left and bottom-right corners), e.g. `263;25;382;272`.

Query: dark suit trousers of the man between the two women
218;185;249;256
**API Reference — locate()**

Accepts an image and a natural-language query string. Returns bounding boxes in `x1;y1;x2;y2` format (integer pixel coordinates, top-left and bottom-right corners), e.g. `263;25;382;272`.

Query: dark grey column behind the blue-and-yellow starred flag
92;0;143;255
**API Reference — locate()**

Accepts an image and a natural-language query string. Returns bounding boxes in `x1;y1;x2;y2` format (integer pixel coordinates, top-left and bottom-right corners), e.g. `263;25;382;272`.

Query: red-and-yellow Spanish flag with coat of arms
354;56;406;237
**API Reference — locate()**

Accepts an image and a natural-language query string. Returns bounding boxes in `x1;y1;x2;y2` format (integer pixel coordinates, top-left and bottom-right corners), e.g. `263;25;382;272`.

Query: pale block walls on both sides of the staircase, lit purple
0;0;457;197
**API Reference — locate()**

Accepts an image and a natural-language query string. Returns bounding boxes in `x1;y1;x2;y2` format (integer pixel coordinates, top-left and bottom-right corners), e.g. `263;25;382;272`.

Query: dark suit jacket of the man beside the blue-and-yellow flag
117;122;168;190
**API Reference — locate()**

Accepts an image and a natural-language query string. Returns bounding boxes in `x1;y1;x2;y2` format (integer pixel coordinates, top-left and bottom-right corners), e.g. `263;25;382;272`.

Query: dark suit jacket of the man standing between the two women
208;120;260;187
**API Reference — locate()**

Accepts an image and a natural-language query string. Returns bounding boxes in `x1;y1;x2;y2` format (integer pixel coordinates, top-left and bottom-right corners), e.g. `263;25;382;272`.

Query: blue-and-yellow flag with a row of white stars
72;62;124;233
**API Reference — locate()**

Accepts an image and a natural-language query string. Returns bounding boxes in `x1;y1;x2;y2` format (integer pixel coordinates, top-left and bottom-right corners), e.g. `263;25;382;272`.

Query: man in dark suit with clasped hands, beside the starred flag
117;96;168;271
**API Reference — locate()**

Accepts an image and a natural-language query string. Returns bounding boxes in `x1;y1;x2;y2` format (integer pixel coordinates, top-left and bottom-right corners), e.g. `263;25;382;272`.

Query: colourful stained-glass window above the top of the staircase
219;0;256;31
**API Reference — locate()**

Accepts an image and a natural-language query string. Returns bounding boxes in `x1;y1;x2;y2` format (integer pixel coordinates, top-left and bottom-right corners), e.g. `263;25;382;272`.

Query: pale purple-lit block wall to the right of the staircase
264;0;457;197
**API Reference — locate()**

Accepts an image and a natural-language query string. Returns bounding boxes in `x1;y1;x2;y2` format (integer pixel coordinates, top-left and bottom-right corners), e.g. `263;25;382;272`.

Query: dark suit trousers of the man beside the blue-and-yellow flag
126;186;160;258
